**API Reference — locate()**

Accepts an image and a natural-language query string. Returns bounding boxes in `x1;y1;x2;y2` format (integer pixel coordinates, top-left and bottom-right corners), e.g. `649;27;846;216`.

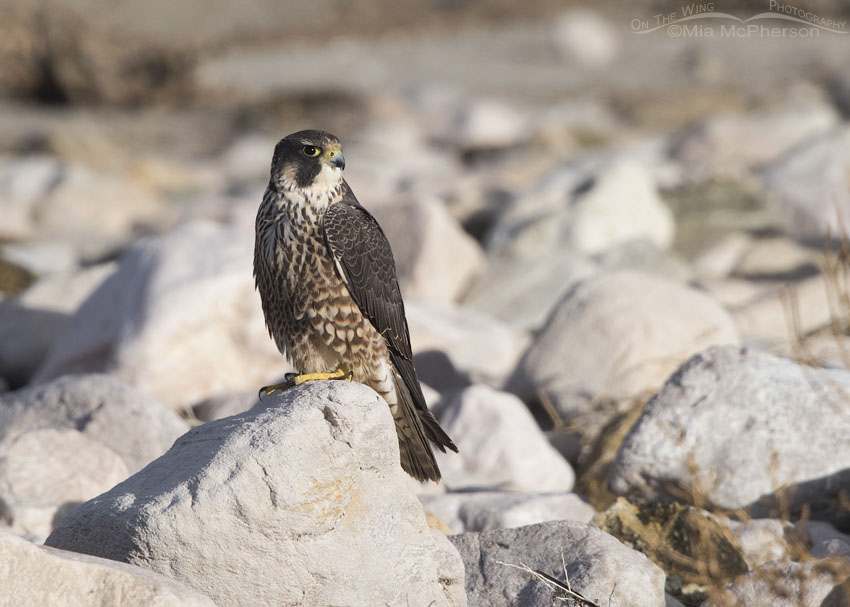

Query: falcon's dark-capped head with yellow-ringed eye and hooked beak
271;131;345;191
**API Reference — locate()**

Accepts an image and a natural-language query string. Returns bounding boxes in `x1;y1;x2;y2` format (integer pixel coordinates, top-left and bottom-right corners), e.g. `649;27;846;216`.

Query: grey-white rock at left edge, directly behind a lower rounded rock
0;375;189;472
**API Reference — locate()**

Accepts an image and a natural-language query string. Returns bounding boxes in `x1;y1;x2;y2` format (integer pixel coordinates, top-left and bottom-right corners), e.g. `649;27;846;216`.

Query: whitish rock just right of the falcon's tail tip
436;385;575;492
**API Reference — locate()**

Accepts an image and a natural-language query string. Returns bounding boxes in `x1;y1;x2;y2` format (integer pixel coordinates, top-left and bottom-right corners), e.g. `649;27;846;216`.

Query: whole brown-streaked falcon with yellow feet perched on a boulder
254;131;457;481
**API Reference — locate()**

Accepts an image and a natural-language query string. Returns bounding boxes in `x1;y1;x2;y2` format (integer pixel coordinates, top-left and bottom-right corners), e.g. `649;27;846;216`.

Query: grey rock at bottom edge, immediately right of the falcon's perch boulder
450;521;664;607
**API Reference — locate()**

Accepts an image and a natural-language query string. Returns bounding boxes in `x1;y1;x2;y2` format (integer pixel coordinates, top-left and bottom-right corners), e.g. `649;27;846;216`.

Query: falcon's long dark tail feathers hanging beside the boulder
394;368;457;482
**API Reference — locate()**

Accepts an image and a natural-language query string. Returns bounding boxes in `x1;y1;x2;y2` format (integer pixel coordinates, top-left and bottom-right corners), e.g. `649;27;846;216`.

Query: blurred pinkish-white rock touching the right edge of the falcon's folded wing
370;199;485;302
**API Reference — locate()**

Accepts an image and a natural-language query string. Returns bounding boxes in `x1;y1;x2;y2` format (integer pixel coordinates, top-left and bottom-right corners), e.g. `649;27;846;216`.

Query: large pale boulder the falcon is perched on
47;382;466;607
